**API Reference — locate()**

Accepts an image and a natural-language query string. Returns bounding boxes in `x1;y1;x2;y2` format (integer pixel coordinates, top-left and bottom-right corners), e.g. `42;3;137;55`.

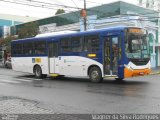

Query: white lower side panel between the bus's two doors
59;56;103;77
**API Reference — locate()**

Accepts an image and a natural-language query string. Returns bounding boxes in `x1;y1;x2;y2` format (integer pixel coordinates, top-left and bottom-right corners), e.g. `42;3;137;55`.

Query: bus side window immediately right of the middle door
60;38;71;53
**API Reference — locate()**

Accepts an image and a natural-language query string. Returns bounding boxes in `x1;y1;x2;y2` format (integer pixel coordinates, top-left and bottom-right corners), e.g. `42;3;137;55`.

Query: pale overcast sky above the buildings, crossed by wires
0;0;137;18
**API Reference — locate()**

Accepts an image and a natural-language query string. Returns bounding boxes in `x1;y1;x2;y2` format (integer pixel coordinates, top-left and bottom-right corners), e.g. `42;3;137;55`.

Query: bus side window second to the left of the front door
71;37;83;52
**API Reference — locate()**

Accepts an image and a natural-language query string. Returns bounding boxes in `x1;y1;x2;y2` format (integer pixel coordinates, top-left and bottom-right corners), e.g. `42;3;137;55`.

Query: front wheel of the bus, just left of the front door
89;66;103;83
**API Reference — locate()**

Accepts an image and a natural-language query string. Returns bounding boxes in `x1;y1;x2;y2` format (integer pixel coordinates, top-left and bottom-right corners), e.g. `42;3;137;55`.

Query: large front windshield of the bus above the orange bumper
125;33;149;58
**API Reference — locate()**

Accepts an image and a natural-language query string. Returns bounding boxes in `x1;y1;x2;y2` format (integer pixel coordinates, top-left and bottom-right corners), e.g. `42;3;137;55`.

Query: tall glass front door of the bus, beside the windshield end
104;36;119;76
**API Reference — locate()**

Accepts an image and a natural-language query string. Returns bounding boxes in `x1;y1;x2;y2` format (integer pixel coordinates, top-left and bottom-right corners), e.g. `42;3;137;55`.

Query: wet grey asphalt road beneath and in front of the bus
0;68;160;114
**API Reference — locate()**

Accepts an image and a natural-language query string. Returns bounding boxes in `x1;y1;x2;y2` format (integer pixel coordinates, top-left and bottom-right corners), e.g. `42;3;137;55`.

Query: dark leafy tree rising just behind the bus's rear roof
18;22;39;38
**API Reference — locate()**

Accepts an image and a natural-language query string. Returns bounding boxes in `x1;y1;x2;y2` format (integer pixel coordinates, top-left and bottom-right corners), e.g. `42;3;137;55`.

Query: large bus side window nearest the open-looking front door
84;35;100;53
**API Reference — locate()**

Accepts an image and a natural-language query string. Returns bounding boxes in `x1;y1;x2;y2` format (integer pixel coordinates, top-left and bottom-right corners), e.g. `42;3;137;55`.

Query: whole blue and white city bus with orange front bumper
11;27;151;82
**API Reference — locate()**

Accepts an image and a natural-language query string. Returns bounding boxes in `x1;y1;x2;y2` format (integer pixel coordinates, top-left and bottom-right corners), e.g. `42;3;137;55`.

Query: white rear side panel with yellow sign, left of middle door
12;57;49;74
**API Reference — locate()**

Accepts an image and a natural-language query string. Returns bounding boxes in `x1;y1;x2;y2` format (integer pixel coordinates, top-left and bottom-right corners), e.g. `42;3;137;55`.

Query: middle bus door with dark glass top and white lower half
48;42;59;73
